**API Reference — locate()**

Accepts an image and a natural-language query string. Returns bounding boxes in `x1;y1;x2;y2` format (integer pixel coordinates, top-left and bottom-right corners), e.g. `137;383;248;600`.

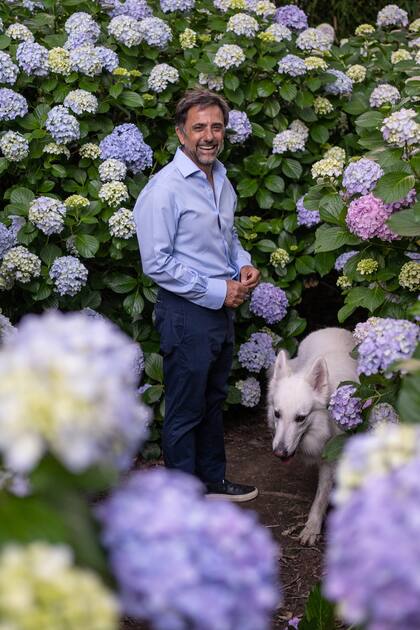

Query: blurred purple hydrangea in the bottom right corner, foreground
324;460;420;630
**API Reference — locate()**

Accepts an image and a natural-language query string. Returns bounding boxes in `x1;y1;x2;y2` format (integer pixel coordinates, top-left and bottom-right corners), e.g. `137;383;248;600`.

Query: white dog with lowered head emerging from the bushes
267;328;357;545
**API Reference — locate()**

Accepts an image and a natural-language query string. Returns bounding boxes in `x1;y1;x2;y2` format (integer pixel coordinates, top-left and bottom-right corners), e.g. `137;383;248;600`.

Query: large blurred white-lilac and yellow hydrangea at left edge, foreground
0;311;149;473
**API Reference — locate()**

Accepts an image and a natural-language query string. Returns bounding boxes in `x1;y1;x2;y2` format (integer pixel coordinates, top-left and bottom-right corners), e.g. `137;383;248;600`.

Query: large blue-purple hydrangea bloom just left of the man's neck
99;123;153;174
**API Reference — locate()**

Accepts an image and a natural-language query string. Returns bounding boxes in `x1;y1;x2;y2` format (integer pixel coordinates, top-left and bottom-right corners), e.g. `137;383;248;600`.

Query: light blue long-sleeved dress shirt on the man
134;149;251;309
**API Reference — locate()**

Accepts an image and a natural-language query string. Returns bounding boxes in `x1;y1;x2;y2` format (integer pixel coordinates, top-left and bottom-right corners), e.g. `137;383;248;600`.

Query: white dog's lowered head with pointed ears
267;350;329;461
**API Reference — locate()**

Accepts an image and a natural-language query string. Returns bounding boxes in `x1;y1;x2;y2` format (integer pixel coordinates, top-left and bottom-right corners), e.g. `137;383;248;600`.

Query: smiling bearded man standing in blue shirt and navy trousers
134;89;260;501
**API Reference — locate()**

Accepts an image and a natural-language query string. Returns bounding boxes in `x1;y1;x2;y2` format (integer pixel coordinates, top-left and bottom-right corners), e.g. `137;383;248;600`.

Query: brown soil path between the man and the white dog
122;408;323;630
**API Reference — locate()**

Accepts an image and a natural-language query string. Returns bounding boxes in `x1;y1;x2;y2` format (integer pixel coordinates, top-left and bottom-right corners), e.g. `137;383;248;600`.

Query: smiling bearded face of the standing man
176;105;225;171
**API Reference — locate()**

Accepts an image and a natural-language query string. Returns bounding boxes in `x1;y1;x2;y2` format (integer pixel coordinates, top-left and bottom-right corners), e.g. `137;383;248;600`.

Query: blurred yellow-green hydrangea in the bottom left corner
0;541;118;630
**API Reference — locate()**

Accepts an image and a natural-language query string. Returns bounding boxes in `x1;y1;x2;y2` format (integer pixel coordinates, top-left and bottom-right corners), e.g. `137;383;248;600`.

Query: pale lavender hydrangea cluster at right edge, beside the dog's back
354;317;420;376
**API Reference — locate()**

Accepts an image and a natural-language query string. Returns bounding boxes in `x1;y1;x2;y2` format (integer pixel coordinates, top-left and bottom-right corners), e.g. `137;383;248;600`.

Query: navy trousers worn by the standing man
155;289;234;482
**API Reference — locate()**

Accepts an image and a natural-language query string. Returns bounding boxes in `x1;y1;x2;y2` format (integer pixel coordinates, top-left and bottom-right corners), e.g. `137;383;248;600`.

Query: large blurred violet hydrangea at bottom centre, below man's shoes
97;468;281;630
